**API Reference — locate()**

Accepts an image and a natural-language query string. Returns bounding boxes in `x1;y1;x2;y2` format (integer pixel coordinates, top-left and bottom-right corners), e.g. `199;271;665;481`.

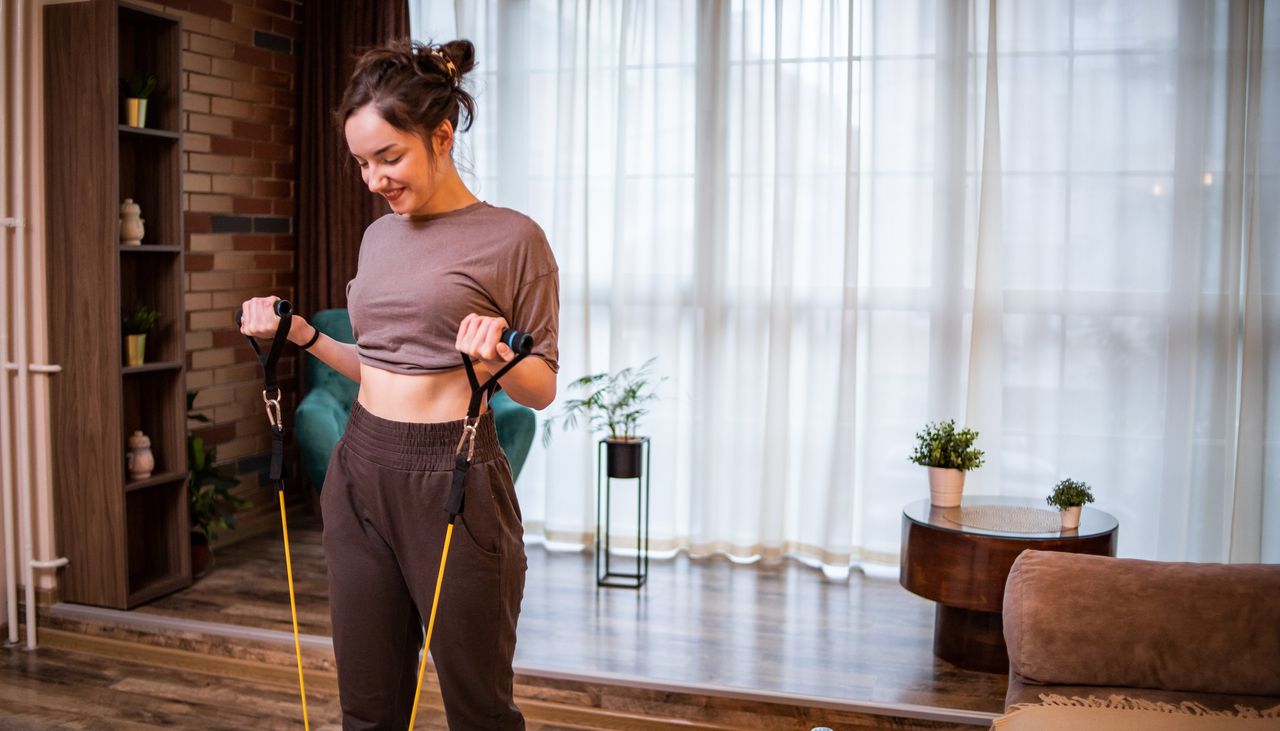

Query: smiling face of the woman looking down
344;104;453;214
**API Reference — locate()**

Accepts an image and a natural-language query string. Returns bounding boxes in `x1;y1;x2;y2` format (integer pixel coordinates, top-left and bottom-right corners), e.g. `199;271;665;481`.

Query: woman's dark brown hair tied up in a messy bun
335;38;476;155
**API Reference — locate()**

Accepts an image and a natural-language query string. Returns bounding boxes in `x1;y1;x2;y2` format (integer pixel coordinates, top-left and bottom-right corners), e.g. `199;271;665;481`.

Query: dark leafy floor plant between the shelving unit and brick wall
187;390;253;579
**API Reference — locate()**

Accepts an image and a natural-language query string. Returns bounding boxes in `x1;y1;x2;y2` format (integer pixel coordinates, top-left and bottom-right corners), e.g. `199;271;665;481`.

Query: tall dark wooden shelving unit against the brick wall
45;0;191;608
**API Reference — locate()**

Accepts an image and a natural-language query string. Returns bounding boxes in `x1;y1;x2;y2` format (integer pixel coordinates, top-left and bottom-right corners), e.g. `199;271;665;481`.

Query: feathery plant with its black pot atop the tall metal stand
543;358;657;478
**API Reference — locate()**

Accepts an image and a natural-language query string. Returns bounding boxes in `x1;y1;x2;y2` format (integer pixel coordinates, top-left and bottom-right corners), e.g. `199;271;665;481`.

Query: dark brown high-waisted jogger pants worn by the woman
320;401;527;731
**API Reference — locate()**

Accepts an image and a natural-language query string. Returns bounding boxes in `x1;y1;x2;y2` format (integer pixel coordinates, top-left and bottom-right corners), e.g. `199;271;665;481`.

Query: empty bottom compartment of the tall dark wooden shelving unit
124;475;191;607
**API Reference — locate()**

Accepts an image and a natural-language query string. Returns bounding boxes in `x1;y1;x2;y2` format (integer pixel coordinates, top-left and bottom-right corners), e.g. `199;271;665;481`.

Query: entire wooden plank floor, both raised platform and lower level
0;520;1006;731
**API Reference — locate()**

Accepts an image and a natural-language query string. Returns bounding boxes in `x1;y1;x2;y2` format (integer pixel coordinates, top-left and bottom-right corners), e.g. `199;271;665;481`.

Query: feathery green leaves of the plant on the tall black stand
543;358;666;444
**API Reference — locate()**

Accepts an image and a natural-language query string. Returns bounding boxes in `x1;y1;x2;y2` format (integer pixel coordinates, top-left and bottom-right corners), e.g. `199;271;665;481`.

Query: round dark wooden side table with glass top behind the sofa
899;495;1120;672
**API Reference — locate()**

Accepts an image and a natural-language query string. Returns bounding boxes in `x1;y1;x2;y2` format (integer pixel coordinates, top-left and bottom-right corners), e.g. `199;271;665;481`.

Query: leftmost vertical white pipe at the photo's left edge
0;4;20;645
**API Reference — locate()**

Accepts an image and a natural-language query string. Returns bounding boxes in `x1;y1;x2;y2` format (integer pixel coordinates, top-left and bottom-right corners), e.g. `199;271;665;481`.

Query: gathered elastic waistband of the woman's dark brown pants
342;401;502;471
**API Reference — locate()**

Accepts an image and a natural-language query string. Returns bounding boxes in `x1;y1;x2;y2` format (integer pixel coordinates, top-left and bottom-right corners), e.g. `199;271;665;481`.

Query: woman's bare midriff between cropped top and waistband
356;364;489;422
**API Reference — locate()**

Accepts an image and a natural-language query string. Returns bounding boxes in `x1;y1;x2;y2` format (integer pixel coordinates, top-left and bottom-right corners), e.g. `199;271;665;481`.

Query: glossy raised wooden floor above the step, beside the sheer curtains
132;520;1006;713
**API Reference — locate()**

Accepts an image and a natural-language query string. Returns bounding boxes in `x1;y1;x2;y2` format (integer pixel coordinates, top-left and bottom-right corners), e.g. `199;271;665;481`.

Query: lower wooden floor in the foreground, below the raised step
0;630;972;731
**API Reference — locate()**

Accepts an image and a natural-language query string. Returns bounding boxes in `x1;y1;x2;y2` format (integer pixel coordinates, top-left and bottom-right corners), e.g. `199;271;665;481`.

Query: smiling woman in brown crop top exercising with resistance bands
241;41;559;731
